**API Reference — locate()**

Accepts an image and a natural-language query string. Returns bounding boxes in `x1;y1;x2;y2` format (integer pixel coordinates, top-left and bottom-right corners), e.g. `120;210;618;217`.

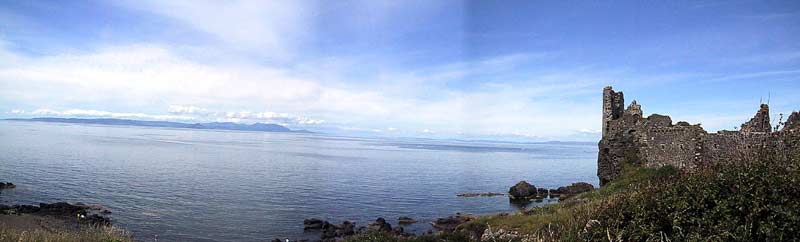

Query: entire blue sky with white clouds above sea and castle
0;0;800;141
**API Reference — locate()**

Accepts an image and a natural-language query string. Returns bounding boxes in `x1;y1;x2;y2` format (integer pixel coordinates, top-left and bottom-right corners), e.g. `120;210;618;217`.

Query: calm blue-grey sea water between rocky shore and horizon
0;121;598;241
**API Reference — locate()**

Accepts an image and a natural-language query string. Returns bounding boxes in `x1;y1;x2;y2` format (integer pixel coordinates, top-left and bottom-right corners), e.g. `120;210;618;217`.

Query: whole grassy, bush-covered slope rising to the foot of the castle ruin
345;158;800;242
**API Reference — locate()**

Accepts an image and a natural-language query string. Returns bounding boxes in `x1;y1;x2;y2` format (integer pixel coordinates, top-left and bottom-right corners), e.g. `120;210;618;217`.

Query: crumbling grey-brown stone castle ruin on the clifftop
597;87;800;186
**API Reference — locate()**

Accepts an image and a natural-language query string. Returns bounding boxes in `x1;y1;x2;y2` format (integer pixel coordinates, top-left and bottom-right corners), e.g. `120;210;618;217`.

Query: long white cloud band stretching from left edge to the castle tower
0;42;611;137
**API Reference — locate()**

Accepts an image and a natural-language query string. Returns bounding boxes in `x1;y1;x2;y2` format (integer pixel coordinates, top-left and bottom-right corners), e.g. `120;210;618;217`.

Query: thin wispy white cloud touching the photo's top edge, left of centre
119;0;315;59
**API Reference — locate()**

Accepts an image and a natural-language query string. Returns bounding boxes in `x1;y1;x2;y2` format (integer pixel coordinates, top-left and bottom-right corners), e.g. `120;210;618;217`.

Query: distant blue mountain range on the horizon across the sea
6;118;313;133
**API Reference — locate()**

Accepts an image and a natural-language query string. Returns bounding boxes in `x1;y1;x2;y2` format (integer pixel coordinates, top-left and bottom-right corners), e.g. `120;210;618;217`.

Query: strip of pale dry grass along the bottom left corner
0;226;133;242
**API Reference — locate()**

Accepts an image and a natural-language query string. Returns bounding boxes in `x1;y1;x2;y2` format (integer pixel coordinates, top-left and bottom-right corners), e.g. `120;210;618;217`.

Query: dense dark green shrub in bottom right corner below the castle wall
583;159;800;241
